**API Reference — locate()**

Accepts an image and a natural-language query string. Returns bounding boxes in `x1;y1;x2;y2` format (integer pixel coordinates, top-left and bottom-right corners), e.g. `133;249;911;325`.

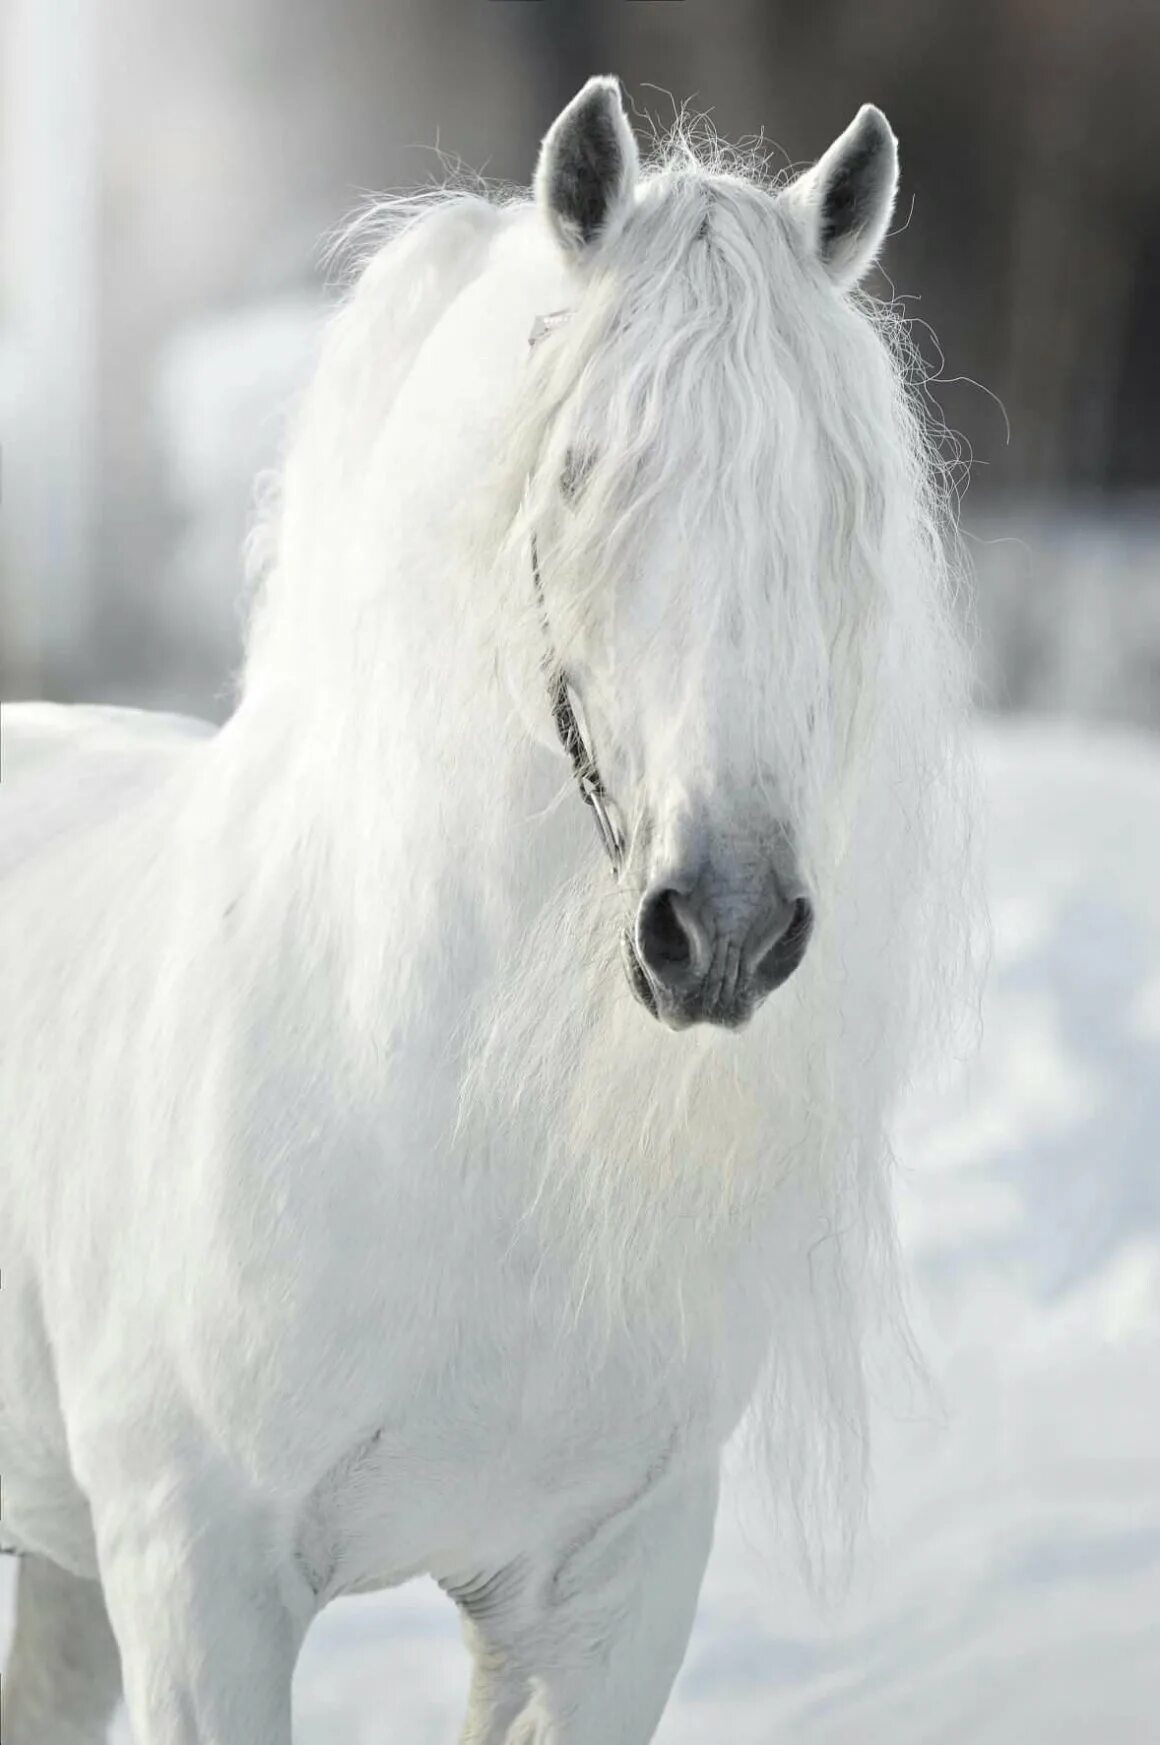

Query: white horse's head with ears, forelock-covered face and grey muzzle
527;79;898;1030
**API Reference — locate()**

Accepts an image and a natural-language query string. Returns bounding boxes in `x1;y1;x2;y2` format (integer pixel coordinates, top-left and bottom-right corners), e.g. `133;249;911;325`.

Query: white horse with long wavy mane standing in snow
0;79;968;1745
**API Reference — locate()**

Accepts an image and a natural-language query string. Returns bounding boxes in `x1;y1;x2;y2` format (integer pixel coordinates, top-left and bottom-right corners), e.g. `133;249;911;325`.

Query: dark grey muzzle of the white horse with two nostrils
624;869;813;1030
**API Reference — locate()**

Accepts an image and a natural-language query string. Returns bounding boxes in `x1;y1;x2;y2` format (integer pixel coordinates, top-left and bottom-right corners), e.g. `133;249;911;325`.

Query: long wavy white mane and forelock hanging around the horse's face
241;136;972;1591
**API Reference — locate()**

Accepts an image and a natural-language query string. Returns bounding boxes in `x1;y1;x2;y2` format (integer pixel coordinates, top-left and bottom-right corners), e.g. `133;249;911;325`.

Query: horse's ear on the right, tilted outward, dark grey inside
783;103;898;290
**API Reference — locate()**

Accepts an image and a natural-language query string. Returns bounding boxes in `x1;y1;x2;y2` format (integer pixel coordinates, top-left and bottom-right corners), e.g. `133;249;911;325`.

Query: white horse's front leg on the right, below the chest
459;1469;717;1745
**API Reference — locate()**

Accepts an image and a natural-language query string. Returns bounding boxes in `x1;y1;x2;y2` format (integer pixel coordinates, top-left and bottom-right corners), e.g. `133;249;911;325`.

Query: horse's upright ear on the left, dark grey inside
536;79;638;258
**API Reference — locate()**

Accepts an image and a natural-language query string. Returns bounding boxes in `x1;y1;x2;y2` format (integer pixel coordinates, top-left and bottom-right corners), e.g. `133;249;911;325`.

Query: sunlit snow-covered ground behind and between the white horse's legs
0;722;1160;1745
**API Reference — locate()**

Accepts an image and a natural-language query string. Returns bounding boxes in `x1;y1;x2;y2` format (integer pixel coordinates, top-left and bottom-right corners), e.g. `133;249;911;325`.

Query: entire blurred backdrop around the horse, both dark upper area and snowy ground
0;0;1160;1745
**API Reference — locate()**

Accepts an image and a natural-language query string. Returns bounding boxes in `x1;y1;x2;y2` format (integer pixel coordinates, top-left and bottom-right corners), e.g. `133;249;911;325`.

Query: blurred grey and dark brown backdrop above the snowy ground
0;0;1160;724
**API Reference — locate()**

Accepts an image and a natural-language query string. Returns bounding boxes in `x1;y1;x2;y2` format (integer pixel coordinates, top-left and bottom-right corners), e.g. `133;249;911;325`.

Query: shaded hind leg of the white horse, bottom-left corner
0;1557;120;1745
